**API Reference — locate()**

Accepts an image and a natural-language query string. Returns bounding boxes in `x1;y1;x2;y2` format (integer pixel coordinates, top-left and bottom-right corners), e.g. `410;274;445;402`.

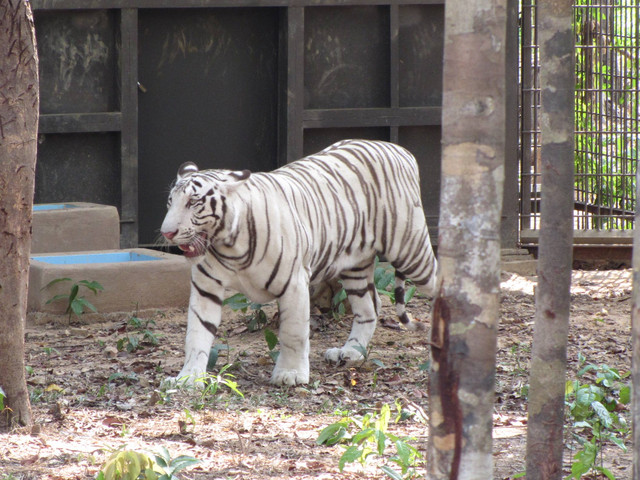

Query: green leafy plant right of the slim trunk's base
565;355;631;479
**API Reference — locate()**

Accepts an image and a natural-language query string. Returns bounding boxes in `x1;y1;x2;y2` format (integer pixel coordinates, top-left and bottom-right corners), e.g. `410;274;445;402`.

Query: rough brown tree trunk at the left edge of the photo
0;0;39;425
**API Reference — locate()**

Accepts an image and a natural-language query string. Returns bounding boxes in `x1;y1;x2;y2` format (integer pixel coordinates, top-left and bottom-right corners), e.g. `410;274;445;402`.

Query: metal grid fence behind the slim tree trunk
520;0;640;244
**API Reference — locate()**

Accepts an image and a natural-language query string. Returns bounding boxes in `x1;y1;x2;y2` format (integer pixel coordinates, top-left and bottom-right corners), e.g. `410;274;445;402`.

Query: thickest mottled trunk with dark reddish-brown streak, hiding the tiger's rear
427;0;507;480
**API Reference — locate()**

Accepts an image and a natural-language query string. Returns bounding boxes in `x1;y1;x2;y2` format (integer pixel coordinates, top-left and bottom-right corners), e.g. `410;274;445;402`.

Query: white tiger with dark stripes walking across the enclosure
161;140;437;385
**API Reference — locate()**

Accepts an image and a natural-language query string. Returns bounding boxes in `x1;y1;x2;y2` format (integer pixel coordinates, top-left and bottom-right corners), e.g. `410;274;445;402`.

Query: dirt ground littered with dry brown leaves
0;270;631;480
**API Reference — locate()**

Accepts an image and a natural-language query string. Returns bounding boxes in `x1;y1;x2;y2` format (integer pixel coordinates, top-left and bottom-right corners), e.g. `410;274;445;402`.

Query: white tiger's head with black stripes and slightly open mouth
160;162;251;257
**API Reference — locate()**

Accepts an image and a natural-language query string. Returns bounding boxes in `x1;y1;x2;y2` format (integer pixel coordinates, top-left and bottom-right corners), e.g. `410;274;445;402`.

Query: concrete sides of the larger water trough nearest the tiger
28;248;191;314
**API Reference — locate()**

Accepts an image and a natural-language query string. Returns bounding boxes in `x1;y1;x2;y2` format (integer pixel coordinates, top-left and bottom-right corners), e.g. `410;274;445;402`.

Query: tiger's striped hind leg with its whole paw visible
324;260;381;363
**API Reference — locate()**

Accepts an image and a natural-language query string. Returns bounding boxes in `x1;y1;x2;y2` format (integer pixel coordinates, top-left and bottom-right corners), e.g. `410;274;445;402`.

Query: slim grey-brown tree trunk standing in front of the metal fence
527;0;575;480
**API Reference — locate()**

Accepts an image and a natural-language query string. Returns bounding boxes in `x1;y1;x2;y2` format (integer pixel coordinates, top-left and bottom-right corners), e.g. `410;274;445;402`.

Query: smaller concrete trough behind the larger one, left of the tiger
31;202;120;253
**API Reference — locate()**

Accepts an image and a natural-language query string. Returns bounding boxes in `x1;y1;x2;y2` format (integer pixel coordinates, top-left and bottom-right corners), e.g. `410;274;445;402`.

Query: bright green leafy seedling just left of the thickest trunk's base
316;401;422;480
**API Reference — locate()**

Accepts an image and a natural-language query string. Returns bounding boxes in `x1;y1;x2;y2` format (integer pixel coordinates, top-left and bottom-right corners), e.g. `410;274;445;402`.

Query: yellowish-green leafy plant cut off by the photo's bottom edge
96;446;200;480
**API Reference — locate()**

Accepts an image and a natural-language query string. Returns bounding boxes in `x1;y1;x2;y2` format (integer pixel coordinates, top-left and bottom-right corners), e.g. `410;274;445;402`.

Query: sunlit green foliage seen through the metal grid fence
574;0;639;230
